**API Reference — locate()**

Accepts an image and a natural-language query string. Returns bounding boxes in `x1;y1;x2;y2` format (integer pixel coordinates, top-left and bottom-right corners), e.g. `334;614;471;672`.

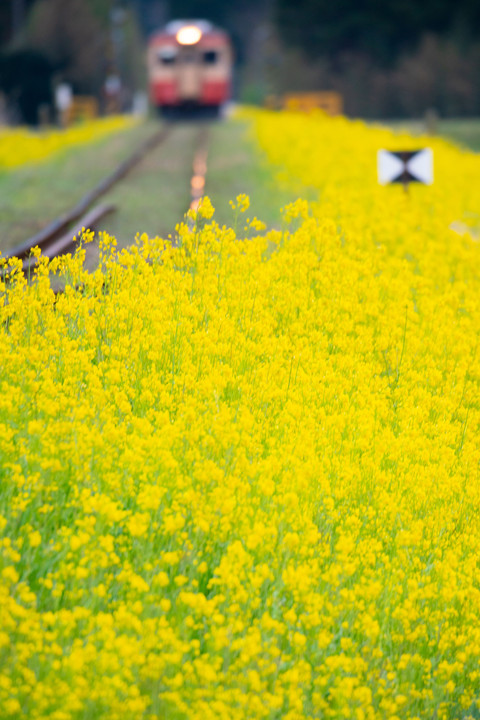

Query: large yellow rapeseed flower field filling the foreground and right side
0;111;480;720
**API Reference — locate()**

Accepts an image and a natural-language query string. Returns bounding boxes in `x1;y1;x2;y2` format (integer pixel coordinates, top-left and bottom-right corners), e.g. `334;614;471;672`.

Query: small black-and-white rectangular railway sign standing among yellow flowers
377;148;433;188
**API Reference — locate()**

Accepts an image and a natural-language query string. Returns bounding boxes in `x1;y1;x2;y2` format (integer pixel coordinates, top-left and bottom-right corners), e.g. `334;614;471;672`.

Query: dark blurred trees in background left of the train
0;0;146;124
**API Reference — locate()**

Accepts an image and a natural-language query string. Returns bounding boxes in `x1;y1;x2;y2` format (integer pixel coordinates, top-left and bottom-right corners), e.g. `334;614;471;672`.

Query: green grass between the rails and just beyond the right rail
102;120;302;247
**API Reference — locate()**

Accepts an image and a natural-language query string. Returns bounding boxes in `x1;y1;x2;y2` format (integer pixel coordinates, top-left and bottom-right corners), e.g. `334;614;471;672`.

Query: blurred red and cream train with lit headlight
148;20;232;115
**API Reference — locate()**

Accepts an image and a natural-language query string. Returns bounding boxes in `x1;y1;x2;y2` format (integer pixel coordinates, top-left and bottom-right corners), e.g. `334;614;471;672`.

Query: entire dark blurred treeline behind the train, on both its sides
0;0;480;122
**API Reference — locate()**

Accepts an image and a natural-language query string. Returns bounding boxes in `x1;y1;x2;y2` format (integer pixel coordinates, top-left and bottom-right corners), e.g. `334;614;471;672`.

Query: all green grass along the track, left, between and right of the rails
0;112;295;256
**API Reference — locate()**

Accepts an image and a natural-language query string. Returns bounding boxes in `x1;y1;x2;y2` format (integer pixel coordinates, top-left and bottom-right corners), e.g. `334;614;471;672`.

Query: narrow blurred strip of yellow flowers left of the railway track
0;115;136;172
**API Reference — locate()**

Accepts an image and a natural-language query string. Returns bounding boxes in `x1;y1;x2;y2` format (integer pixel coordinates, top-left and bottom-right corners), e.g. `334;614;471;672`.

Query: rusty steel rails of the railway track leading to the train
6;125;209;273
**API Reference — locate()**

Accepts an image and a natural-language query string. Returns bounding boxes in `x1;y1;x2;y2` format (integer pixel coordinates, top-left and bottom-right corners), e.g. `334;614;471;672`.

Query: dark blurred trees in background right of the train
272;0;480;117
